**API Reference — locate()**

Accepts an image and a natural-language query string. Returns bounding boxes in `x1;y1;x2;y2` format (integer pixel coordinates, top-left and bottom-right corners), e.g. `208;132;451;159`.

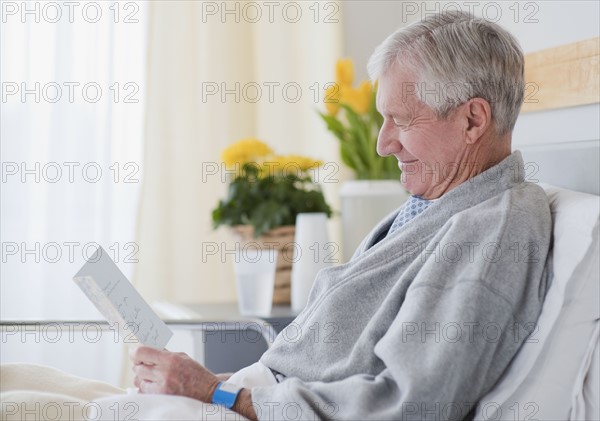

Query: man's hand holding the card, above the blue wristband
130;346;220;403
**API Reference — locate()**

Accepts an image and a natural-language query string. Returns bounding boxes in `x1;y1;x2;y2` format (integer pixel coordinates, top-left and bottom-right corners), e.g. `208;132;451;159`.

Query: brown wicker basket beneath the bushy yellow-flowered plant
232;225;295;305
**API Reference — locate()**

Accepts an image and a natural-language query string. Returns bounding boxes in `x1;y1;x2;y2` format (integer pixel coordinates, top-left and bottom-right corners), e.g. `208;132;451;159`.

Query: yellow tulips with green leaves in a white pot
319;59;408;260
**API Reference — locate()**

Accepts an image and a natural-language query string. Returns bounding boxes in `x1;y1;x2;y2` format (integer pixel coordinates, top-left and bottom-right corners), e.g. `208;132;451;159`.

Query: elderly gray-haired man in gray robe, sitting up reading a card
132;9;551;420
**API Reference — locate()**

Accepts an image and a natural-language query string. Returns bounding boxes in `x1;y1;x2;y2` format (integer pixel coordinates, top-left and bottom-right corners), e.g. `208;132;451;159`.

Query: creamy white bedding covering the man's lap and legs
0;363;276;421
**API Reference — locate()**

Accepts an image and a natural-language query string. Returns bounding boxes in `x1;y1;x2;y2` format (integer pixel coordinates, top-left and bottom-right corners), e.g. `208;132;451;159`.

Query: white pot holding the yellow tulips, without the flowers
340;180;409;262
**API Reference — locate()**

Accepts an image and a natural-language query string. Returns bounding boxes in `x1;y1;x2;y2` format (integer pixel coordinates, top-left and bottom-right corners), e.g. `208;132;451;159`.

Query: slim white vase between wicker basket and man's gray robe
291;212;331;312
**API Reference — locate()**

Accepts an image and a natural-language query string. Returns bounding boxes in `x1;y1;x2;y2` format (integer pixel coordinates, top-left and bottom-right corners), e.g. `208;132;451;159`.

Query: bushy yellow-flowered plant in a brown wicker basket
212;139;331;304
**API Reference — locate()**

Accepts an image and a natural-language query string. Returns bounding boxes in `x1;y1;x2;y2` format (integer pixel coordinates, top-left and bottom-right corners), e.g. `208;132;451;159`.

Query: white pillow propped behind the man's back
475;186;600;421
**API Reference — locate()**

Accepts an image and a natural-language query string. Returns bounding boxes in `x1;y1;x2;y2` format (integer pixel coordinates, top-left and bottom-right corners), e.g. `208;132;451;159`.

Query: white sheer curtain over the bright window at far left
0;2;147;378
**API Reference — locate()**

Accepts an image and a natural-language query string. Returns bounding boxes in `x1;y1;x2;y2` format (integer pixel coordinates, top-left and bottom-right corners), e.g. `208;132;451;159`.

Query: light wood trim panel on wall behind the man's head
522;37;600;112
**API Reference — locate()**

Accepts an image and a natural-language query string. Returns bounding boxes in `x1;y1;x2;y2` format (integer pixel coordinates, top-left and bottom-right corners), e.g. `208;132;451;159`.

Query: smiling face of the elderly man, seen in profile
377;63;468;199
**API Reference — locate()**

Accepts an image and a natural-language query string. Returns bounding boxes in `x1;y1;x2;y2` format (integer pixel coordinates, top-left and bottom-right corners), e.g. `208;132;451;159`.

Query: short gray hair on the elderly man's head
367;11;525;135
